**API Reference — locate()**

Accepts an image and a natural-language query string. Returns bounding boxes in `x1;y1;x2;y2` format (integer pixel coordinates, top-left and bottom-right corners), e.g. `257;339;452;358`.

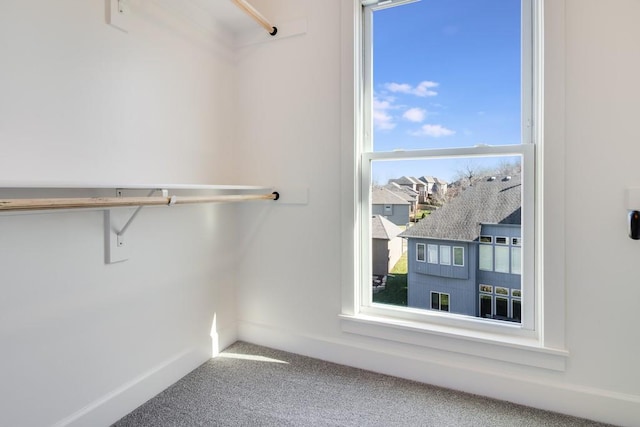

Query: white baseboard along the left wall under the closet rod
53;346;211;427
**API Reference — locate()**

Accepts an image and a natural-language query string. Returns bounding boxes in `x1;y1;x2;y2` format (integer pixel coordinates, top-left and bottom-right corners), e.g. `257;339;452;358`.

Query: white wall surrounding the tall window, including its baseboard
238;0;640;425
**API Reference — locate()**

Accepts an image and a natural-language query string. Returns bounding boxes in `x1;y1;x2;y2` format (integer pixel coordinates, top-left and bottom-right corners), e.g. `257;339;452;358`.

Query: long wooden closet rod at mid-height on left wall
0;191;280;212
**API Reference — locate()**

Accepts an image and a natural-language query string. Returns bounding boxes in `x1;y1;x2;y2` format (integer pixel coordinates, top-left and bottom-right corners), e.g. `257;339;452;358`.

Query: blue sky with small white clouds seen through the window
373;0;521;181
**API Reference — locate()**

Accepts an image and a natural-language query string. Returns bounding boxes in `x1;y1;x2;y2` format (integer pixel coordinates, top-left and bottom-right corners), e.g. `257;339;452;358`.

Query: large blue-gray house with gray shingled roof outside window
400;175;522;321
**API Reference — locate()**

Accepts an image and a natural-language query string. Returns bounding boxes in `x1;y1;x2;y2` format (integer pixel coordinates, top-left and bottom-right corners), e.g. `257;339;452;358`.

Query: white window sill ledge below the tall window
340;314;569;371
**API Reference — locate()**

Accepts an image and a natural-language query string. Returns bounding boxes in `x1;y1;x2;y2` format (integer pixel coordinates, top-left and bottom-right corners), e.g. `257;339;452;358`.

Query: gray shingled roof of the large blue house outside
400;175;522;241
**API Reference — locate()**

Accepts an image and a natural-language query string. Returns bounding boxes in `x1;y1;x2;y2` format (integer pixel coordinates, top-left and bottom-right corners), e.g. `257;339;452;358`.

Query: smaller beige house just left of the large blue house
371;215;403;276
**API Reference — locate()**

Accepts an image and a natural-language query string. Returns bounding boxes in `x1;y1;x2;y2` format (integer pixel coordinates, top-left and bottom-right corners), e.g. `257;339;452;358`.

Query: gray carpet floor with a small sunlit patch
114;342;604;427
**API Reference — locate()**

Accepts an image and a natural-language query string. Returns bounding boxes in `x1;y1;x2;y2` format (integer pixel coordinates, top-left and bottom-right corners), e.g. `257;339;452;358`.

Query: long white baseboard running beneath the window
238;322;640;426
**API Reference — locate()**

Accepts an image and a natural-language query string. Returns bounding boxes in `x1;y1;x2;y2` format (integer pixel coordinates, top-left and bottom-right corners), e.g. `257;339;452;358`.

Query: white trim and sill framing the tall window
340;0;568;371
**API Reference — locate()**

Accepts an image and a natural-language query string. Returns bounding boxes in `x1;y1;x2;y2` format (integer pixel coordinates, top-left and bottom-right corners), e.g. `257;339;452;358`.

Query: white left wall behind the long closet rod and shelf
0;0;242;426
